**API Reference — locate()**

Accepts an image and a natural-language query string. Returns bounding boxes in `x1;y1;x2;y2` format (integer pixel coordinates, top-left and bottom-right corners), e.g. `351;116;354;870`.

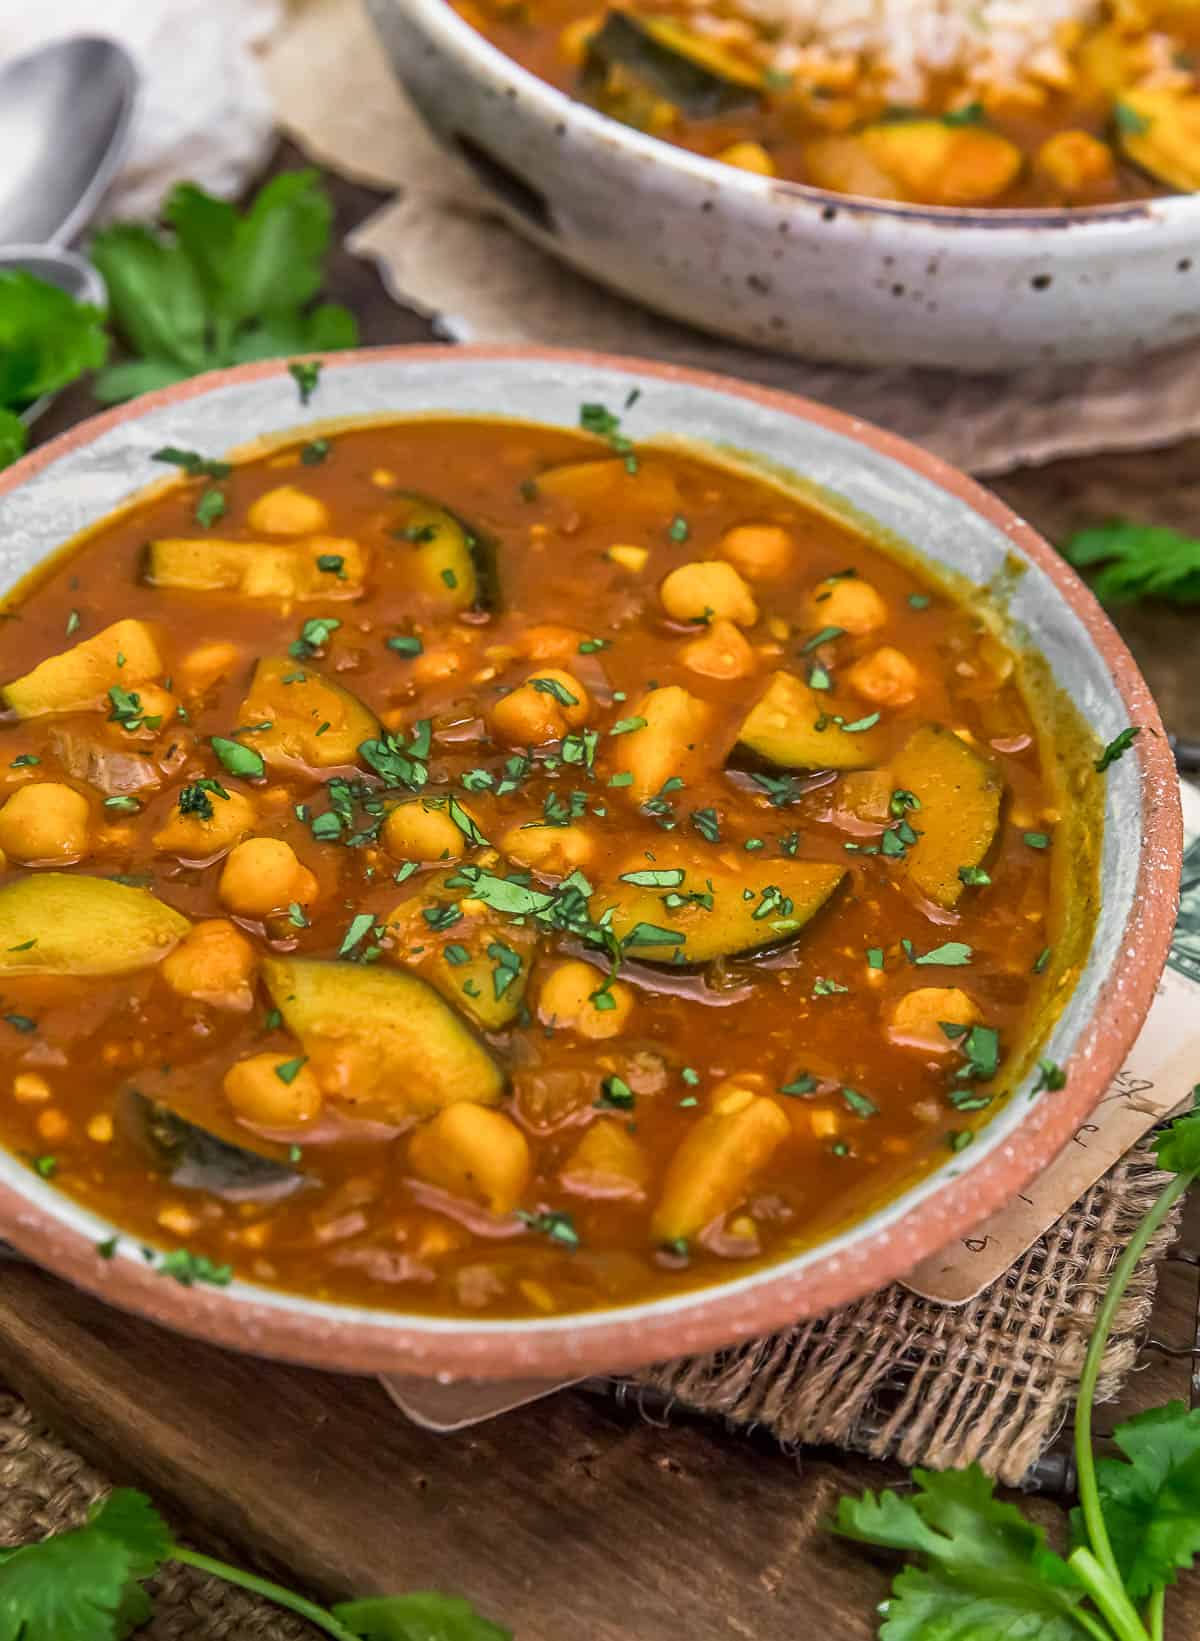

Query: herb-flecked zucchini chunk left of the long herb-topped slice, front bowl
387;866;537;1031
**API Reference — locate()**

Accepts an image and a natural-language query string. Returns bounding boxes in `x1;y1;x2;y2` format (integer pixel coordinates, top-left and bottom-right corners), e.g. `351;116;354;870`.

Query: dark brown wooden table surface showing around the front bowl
16;149;1200;1641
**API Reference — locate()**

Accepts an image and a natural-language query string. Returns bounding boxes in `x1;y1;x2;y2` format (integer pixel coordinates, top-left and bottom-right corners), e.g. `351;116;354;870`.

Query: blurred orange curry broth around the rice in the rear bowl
455;0;1200;208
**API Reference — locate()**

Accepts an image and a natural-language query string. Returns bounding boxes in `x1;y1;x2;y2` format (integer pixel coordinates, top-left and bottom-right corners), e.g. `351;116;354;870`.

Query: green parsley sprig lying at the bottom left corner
0;1488;512;1641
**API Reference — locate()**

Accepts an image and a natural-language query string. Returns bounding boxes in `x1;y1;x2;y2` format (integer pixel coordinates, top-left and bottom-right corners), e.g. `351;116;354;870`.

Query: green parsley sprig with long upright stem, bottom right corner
832;1111;1200;1641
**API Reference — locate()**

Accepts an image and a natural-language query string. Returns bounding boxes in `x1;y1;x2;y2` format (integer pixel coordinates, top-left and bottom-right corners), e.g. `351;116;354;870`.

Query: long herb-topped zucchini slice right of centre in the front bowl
606;850;845;968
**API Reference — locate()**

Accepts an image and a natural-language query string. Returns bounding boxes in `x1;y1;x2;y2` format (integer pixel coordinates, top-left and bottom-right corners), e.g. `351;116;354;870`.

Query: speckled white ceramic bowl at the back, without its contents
366;0;1200;371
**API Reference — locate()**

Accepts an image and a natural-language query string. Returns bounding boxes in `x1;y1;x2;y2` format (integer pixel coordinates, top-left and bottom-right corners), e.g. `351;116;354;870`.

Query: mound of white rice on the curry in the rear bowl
701;0;1105;103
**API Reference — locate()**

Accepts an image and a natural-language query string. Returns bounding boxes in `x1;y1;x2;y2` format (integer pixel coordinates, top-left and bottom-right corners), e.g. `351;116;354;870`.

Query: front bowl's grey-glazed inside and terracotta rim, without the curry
0;348;1182;1380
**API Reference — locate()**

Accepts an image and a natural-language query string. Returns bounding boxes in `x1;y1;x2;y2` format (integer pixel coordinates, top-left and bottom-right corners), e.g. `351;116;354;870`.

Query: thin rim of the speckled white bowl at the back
397;0;1200;235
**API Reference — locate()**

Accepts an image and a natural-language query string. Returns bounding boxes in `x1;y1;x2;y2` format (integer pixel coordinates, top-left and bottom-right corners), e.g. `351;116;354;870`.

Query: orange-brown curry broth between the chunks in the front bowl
0;420;1057;1314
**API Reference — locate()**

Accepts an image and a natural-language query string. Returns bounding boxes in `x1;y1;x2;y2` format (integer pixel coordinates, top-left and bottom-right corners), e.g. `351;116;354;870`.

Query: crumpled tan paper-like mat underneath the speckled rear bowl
266;0;1200;474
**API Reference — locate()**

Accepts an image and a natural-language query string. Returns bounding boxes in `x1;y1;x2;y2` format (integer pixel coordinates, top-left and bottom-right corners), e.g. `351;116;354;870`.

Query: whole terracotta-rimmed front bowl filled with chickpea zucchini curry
0;348;1180;1378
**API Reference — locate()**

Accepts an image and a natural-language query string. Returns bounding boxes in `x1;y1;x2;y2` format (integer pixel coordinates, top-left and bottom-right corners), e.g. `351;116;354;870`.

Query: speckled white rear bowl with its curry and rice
368;0;1200;371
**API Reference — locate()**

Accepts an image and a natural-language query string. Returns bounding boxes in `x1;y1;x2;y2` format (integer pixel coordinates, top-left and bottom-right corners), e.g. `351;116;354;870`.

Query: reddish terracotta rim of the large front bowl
0;346;1182;1380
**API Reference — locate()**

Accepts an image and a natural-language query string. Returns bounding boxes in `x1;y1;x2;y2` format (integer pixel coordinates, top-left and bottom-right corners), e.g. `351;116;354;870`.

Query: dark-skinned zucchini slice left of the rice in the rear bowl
583;11;762;120
